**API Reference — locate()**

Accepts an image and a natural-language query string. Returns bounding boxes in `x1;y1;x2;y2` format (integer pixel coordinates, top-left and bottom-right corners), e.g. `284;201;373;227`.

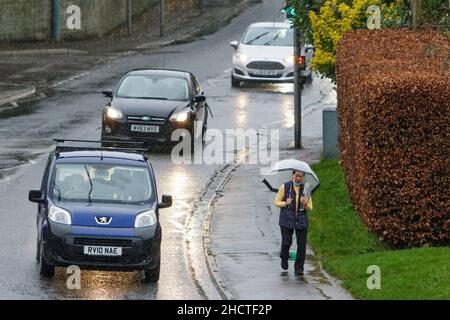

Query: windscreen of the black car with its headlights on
116;75;189;101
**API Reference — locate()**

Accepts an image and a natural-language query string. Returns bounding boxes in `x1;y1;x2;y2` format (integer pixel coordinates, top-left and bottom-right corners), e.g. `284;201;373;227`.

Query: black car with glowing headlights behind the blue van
102;69;209;146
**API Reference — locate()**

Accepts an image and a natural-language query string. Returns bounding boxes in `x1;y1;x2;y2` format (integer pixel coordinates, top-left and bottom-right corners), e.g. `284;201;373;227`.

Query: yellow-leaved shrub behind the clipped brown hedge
309;0;404;81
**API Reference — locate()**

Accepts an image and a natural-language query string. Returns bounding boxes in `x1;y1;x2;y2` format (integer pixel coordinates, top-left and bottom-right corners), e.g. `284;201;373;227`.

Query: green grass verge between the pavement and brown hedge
308;160;450;300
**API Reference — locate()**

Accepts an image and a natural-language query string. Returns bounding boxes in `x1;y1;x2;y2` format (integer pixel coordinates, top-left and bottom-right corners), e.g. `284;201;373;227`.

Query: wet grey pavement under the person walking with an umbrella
204;78;353;300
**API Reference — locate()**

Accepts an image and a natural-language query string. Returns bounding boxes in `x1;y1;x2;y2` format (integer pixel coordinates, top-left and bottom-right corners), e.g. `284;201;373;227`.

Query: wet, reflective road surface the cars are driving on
0;0;334;299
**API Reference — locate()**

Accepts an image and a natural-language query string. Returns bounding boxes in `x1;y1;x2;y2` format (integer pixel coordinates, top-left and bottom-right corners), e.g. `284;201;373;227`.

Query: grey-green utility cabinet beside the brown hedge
322;108;340;159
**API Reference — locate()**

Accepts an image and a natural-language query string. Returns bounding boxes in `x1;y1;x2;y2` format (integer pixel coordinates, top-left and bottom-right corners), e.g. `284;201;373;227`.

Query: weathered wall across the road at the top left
0;0;200;41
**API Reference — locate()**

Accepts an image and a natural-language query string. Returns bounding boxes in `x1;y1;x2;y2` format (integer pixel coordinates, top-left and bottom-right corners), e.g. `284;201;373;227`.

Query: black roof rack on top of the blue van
53;139;148;160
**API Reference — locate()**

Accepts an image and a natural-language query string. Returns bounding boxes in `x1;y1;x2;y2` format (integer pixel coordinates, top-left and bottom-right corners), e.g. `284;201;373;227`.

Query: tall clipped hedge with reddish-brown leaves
336;30;450;247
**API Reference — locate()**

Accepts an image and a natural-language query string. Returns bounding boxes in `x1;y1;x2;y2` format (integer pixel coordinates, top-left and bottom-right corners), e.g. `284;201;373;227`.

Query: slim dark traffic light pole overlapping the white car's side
293;27;302;149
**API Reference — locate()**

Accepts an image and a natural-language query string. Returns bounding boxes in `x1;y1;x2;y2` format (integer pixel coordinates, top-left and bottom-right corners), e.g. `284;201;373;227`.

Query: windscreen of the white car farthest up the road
242;27;294;47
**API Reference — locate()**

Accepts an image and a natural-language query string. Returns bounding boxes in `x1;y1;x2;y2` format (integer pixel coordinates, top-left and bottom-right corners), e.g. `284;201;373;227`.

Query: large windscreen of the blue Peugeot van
52;163;153;204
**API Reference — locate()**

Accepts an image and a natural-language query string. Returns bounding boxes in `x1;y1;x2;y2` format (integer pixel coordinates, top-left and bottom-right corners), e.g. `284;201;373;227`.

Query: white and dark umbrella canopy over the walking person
263;159;320;193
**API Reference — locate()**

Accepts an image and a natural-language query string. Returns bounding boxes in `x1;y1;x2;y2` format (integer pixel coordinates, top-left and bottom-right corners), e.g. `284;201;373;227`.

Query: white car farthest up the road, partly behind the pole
230;22;313;87
